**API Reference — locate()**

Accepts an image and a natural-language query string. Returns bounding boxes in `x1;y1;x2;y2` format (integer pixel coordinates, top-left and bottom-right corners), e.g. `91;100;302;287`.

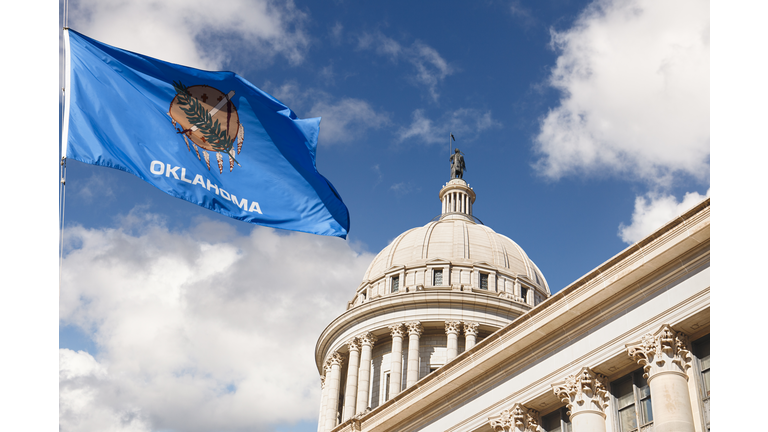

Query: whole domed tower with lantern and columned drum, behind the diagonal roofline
315;171;550;430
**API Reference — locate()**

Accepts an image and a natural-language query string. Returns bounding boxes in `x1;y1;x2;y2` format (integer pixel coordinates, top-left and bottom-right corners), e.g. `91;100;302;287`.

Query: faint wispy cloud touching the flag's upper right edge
262;81;390;145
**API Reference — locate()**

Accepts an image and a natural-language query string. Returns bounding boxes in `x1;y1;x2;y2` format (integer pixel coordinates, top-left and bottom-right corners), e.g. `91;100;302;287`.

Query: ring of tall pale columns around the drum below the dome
318;321;479;432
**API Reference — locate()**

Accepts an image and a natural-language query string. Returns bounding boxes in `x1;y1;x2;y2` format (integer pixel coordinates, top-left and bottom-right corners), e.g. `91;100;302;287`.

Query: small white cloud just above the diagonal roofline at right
619;190;709;244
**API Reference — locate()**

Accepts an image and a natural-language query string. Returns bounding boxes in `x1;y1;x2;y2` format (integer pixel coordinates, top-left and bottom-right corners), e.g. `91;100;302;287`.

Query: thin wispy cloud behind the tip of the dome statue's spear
397;108;501;144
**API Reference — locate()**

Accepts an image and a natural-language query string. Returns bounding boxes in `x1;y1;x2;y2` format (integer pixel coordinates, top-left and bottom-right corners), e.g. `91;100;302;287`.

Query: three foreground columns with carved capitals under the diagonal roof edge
490;324;694;432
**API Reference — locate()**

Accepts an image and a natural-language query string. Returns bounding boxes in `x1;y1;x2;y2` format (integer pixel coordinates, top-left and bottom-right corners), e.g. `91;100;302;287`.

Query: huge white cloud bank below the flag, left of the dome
60;211;373;431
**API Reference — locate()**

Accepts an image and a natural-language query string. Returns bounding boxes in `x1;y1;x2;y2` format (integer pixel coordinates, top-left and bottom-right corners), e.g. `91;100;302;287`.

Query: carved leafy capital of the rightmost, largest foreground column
626;324;691;381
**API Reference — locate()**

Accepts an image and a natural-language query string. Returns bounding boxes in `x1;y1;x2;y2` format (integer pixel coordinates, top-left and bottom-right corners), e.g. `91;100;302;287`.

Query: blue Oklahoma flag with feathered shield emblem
62;30;349;238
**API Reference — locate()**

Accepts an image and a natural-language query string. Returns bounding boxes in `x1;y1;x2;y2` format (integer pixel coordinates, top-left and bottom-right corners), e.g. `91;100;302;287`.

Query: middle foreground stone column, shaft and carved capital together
552;367;609;432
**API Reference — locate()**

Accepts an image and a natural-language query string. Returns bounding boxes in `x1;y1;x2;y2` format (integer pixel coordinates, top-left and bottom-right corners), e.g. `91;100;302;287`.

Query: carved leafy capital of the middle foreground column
552;367;609;418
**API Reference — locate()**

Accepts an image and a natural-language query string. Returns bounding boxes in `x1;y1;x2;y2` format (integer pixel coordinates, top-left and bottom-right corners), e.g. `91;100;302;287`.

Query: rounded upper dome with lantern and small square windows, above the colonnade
348;179;550;307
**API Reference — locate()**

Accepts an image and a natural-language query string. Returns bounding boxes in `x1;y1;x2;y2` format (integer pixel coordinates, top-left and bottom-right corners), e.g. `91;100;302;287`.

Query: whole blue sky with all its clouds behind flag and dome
52;0;710;431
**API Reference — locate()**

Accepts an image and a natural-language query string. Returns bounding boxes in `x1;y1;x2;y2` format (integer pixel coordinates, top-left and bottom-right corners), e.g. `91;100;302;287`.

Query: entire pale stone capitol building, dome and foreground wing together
315;176;710;432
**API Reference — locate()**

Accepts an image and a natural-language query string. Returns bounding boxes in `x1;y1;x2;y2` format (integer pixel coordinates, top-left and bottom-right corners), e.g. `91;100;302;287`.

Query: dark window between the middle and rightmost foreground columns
611;369;653;432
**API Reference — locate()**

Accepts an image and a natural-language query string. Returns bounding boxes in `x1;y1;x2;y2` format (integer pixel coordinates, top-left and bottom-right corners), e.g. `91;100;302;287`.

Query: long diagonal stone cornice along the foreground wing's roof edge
338;199;710;430
